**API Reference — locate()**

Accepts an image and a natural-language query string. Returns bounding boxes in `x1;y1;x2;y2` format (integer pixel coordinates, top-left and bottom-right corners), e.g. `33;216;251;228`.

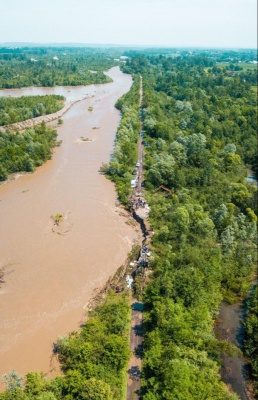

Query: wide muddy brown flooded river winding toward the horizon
0;67;137;388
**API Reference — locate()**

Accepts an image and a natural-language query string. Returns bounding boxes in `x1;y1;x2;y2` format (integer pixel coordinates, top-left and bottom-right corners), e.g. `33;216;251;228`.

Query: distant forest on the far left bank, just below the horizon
0;47;121;89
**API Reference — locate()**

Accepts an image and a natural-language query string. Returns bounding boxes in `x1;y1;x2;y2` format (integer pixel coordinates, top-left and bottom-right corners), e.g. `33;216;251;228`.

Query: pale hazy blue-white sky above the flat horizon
0;0;257;48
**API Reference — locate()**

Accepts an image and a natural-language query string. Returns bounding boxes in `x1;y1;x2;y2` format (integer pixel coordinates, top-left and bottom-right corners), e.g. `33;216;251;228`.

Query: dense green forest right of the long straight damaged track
120;55;257;400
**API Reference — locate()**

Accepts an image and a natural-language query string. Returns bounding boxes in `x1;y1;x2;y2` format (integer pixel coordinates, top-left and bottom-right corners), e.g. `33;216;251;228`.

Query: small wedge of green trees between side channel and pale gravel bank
0;95;64;126
